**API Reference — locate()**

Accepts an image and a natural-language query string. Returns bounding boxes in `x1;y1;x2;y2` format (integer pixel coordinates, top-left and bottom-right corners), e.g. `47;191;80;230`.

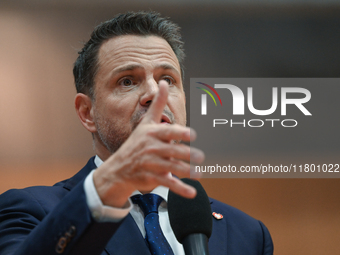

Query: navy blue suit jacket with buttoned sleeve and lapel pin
0;158;273;255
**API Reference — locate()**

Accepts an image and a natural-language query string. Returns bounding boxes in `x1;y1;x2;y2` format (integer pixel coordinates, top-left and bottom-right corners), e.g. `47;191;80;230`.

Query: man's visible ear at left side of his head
74;93;97;133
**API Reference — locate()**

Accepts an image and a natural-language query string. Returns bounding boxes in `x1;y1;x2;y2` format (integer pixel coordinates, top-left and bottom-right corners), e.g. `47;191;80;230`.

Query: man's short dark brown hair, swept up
73;11;185;99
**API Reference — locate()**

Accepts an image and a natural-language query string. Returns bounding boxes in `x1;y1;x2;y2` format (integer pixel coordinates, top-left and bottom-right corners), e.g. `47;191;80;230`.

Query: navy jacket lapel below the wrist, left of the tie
105;214;151;255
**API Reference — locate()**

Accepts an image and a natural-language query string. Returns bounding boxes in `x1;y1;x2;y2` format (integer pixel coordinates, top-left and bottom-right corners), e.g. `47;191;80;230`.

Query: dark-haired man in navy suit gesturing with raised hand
0;12;273;255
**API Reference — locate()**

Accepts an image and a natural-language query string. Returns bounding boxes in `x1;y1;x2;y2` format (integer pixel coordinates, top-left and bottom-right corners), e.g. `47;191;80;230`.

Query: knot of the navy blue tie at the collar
131;194;163;217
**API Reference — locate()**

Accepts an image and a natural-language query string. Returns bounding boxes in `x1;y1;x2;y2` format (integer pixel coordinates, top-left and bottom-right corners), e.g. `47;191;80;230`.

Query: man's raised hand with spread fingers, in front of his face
93;80;204;207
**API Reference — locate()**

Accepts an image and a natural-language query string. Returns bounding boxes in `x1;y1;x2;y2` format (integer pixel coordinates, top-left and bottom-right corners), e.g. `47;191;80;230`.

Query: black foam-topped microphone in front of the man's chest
168;178;212;255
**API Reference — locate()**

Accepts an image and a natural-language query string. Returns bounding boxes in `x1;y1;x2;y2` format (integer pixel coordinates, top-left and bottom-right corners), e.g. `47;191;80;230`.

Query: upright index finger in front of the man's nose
141;80;168;123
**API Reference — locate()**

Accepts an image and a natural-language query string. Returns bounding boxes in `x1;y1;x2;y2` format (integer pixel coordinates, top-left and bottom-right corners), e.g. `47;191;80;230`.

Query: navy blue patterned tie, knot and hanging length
131;194;174;255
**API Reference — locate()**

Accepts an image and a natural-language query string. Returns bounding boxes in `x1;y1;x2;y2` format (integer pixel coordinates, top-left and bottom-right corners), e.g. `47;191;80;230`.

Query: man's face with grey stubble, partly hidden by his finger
92;35;186;153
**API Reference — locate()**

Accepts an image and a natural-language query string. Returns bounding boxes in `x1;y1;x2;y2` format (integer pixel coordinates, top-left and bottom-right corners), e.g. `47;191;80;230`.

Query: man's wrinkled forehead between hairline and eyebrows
98;35;180;71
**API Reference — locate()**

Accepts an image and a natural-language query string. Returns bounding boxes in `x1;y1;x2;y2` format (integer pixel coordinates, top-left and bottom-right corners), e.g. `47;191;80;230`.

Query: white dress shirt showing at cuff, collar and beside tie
84;156;185;255
